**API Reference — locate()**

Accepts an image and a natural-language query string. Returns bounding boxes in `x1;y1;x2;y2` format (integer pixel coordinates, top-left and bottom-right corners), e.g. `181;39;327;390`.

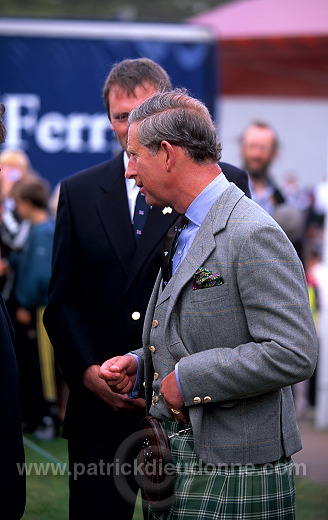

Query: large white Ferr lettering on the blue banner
3;94;111;153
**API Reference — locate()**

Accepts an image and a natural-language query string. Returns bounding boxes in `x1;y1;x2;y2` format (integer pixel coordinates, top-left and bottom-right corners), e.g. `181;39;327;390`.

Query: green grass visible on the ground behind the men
23;435;328;520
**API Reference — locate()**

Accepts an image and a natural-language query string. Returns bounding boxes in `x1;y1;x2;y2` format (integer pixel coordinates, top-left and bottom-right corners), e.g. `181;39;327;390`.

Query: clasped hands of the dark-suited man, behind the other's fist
83;365;145;412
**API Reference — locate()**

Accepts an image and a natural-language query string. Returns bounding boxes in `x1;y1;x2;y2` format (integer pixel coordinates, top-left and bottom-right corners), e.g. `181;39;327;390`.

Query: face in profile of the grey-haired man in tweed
125;123;170;207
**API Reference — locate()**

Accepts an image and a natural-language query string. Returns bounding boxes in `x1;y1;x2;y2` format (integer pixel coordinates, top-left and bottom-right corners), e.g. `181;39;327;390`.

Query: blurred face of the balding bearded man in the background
241;126;276;178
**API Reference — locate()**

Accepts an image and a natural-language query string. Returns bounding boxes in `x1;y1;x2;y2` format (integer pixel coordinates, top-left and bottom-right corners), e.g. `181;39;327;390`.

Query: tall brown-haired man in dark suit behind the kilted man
44;58;248;520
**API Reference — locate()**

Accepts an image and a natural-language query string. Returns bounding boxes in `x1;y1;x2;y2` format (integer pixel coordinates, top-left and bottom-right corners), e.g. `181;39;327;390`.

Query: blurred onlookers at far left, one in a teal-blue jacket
0;149;67;440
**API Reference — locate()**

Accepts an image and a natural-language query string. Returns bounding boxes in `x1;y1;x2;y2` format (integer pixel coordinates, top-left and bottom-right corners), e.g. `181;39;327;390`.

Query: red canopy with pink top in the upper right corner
187;0;328;98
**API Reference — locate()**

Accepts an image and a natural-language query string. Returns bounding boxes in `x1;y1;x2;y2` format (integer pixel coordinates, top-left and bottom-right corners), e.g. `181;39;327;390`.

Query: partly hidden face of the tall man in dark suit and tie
108;83;157;150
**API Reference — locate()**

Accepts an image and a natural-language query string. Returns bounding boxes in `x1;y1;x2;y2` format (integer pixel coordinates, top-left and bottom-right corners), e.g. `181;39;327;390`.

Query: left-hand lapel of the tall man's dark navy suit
96;154;135;275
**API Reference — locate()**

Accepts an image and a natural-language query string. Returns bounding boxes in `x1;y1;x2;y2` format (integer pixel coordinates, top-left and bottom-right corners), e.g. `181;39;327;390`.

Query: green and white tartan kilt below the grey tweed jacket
148;421;295;520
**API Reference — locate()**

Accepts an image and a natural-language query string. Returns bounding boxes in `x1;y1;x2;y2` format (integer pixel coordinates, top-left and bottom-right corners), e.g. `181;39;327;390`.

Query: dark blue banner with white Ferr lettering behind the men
0;23;217;186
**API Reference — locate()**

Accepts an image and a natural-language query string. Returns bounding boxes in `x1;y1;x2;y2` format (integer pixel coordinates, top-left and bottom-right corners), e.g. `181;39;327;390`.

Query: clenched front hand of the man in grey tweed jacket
99;356;138;394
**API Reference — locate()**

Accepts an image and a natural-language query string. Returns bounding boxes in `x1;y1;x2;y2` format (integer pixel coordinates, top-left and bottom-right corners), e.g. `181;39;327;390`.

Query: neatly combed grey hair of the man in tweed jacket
129;89;221;164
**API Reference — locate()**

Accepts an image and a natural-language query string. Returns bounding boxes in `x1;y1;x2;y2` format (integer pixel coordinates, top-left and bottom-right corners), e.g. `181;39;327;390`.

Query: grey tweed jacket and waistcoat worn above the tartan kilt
136;184;318;464
